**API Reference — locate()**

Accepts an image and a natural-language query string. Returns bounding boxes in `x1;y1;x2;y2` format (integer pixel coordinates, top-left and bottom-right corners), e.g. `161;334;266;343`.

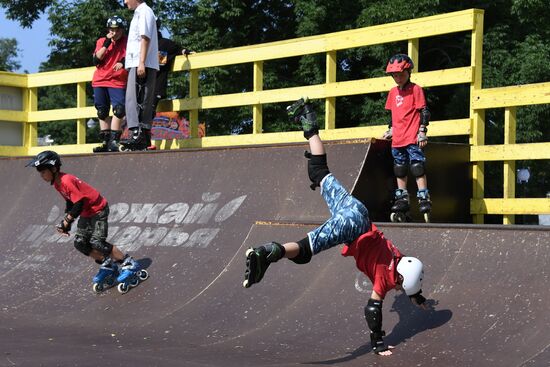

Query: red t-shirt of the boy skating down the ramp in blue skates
53;172;107;218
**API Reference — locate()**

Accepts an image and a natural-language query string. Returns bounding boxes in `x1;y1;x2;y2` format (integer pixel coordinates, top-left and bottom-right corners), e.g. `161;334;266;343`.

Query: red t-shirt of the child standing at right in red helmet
386;83;426;148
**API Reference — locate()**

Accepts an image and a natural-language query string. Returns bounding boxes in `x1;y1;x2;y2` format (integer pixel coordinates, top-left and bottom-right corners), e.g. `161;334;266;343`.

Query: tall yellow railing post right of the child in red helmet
470;11;485;224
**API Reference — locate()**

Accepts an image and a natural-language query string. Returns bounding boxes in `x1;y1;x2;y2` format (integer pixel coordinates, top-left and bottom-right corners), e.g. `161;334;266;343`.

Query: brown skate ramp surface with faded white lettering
0;142;550;366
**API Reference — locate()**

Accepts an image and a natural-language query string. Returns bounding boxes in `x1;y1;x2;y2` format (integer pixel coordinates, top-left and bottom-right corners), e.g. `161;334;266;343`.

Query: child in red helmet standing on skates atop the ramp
383;54;432;222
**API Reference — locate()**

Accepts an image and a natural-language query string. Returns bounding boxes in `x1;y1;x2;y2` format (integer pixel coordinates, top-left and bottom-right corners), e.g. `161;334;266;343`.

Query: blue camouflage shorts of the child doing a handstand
307;174;369;255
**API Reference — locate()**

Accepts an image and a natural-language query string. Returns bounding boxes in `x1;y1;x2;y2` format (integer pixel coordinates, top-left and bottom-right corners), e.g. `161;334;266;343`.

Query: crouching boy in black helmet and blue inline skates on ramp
27;150;149;293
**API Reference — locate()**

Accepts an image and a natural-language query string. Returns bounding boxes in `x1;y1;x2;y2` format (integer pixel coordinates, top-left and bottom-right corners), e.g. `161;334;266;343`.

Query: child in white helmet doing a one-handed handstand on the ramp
243;99;427;356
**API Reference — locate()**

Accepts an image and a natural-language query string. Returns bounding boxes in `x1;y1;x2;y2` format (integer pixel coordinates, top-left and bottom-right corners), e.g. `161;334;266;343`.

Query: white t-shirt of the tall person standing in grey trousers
124;2;159;70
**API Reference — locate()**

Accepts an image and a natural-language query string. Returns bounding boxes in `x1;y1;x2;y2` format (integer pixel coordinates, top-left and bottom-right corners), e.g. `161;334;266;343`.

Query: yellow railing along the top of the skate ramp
0;9;550;223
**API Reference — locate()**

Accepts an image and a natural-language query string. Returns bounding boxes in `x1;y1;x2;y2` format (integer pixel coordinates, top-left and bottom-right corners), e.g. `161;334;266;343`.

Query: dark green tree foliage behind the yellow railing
0;0;550;148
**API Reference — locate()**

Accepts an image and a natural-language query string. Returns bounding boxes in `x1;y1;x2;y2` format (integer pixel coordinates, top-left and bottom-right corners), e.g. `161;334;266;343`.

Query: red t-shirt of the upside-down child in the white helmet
342;224;403;298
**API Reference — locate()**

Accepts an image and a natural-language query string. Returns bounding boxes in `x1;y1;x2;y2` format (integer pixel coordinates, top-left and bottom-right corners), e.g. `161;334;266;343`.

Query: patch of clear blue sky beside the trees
0;8;50;73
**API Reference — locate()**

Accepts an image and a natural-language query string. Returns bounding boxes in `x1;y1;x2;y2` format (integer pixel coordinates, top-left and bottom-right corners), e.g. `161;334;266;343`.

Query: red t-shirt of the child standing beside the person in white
92;36;128;88
